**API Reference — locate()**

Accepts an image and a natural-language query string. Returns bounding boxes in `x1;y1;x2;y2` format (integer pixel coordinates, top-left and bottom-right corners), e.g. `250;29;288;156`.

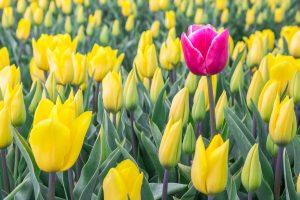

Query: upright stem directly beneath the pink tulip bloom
206;76;216;137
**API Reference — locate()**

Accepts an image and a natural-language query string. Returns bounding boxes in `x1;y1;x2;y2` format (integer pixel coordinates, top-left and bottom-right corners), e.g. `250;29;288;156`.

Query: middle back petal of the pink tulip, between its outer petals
189;25;217;58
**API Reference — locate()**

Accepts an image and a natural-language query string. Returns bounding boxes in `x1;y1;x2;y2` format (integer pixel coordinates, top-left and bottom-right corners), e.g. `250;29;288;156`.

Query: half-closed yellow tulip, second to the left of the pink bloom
135;44;158;78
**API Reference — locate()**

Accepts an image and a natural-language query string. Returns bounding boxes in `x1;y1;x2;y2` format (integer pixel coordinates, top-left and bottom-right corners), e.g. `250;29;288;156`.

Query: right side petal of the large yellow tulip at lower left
63;112;92;170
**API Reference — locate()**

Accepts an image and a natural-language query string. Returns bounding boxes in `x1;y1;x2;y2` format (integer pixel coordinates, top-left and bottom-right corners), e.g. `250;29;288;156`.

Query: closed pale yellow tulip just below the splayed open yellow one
102;71;123;113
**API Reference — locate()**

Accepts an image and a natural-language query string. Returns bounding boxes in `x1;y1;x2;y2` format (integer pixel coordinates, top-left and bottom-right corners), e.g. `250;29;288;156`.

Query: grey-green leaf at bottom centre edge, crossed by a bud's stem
149;183;187;199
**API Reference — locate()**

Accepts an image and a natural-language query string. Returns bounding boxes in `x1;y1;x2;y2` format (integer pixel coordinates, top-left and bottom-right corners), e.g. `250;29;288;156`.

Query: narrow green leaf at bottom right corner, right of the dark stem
283;150;298;199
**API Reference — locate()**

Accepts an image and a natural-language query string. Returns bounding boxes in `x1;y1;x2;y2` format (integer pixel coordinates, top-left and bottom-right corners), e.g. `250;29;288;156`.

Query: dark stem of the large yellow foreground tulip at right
274;146;284;200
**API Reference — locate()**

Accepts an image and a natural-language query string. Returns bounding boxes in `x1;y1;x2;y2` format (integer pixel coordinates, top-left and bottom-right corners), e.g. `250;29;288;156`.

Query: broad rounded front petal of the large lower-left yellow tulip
29;119;71;172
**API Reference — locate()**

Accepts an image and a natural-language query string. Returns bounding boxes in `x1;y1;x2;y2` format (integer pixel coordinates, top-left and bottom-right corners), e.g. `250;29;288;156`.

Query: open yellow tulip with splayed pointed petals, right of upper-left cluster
87;44;124;82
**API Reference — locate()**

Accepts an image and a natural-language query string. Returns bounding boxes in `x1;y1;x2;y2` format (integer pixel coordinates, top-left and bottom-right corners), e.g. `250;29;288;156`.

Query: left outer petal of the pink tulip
181;33;206;75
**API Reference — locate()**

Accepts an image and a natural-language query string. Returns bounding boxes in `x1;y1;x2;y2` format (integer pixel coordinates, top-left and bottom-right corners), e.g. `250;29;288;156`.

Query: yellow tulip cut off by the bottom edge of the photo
103;160;144;200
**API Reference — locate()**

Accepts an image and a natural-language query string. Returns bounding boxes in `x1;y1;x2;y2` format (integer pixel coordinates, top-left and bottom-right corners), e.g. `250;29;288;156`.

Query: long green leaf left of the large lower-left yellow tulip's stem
13;129;43;199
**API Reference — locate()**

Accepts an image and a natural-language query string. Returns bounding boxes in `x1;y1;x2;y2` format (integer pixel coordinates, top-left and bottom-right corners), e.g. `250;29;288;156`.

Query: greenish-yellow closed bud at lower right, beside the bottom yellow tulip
241;144;262;192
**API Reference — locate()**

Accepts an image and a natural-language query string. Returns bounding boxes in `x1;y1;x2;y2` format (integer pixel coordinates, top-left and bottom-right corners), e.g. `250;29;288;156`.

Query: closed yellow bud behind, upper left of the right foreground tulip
258;81;279;122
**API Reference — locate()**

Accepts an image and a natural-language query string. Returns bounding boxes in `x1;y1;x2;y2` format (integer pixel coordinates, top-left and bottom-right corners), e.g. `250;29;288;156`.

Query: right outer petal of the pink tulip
205;29;229;74
